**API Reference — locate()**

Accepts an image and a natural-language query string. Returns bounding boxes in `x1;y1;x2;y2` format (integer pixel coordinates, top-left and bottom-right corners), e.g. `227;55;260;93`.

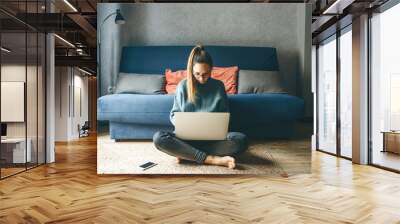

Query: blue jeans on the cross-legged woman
153;131;248;164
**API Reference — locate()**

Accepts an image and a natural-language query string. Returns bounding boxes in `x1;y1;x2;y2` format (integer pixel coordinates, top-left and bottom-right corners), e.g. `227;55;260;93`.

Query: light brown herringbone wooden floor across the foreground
0;134;400;224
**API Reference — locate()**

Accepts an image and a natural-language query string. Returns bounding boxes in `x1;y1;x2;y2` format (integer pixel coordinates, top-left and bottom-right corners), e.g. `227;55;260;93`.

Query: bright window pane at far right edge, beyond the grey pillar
371;4;400;170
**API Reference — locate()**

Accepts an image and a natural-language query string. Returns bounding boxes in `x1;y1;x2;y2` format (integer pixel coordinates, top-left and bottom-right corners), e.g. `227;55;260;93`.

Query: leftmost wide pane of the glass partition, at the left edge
0;32;27;177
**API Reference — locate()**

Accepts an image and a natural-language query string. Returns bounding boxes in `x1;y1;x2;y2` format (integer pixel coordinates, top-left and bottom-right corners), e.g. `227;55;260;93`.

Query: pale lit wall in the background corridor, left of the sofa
55;67;88;141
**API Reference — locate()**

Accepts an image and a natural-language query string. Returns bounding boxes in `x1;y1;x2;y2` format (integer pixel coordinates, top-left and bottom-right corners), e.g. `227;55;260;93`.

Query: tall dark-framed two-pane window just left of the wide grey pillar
316;25;353;159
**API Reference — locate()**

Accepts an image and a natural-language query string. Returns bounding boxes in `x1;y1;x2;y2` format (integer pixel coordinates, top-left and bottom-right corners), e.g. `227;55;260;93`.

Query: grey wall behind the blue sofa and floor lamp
97;3;312;116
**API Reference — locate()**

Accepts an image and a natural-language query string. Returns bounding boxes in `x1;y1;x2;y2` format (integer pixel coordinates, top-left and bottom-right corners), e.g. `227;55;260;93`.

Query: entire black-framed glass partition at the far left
0;1;46;179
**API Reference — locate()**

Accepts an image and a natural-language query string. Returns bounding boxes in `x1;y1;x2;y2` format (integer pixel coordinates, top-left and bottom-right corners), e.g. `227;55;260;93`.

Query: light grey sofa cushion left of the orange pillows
115;73;165;94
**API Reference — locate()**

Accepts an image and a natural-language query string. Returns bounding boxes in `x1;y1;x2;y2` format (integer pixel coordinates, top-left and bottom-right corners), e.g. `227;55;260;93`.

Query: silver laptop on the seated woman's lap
174;112;230;140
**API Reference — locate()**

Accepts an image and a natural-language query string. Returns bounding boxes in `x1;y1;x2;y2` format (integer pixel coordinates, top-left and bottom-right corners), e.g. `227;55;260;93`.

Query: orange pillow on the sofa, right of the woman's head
211;66;239;94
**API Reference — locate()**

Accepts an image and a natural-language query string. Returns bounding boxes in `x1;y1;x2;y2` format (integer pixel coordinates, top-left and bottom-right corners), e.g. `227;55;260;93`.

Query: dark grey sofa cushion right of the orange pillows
238;70;287;93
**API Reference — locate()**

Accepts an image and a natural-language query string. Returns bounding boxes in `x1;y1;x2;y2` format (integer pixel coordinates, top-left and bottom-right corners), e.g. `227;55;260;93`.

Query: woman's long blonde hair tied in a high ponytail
186;45;213;103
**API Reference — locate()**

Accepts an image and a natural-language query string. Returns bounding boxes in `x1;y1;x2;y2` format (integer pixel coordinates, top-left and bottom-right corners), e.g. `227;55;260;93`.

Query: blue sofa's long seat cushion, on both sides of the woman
98;93;304;127
